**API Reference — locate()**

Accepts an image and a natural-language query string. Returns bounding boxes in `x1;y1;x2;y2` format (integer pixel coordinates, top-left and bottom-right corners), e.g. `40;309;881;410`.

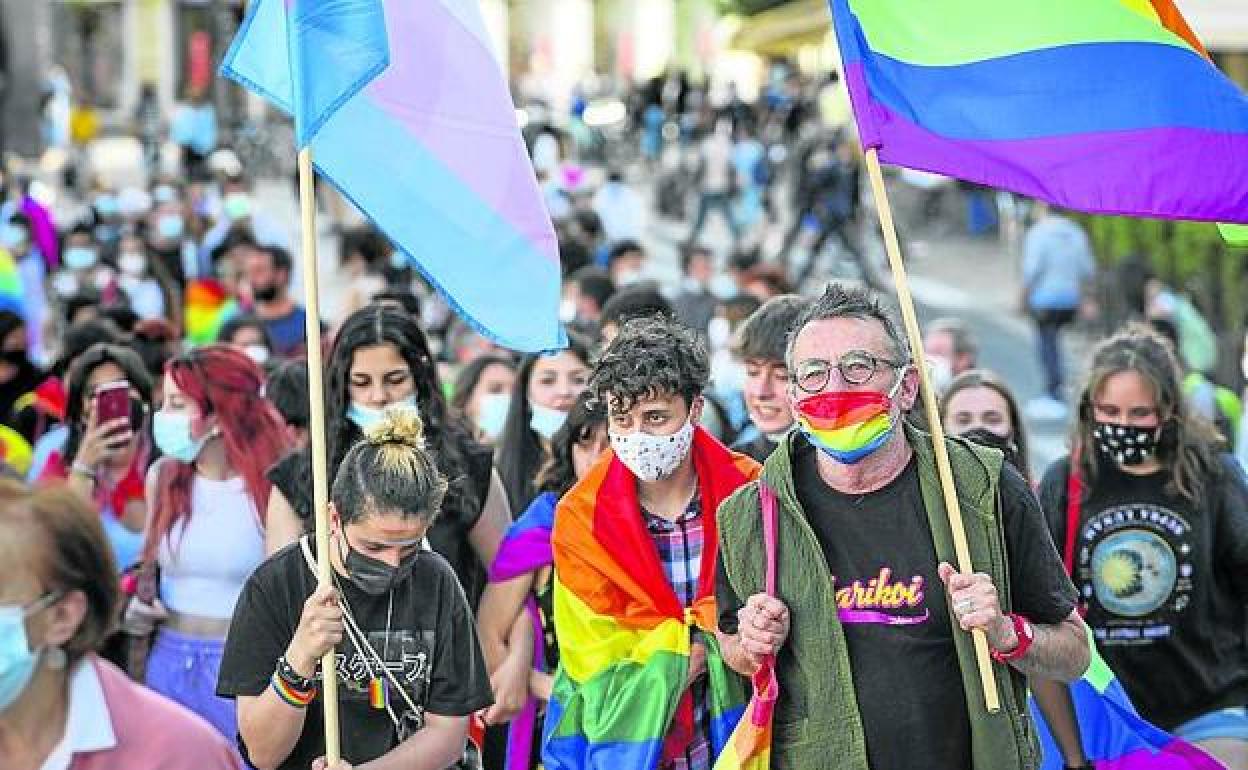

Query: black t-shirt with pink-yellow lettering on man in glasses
716;439;1075;770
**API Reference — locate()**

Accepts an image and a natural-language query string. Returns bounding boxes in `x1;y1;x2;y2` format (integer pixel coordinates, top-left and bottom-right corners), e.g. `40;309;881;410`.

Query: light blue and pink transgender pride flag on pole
222;0;565;352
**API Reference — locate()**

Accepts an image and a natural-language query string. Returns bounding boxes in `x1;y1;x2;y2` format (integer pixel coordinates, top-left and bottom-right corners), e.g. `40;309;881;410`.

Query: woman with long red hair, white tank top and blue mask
122;344;290;741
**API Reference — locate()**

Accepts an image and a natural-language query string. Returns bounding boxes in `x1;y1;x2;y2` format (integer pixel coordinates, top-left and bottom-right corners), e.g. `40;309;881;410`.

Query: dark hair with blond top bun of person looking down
331;404;447;522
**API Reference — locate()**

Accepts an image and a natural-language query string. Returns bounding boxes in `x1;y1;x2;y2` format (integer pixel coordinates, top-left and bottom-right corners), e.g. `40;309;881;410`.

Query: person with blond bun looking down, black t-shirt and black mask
217;406;492;770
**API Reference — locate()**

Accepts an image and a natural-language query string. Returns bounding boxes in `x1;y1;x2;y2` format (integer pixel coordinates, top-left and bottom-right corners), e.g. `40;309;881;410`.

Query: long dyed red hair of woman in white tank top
144;344;290;560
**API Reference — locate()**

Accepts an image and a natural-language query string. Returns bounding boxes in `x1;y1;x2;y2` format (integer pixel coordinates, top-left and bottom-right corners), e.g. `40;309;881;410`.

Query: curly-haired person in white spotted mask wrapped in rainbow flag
542;317;759;770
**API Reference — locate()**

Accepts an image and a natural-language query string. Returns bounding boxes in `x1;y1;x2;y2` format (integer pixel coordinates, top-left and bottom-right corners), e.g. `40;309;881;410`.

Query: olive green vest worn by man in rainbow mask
718;426;1040;770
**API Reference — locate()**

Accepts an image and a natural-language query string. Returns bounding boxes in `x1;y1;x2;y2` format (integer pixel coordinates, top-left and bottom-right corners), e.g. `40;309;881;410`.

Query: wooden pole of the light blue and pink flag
300;147;342;768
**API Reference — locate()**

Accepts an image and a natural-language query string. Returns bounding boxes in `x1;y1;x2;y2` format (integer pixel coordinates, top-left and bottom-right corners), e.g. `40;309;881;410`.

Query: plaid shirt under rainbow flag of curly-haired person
641;495;710;770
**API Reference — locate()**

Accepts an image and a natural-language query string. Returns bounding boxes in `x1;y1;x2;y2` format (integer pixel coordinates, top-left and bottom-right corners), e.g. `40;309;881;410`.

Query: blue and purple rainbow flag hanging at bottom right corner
1028;630;1222;770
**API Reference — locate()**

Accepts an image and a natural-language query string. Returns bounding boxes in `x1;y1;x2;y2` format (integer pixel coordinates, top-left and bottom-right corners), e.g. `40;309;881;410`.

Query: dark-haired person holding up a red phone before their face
41;343;152;570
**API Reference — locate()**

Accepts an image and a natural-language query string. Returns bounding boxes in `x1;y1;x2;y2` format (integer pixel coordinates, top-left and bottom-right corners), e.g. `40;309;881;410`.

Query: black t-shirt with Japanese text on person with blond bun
217;542;493;770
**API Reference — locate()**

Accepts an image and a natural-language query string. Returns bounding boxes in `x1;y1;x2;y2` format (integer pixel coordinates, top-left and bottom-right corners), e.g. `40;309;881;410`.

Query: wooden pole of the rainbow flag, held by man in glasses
866;147;1001;714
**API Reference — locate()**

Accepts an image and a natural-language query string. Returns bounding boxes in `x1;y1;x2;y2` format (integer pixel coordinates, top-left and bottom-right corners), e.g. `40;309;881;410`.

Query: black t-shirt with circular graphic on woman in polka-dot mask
1040;456;1248;729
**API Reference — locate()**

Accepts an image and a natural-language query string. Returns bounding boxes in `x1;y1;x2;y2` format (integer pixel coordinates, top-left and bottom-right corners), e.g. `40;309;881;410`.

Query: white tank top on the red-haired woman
160;475;265;618
